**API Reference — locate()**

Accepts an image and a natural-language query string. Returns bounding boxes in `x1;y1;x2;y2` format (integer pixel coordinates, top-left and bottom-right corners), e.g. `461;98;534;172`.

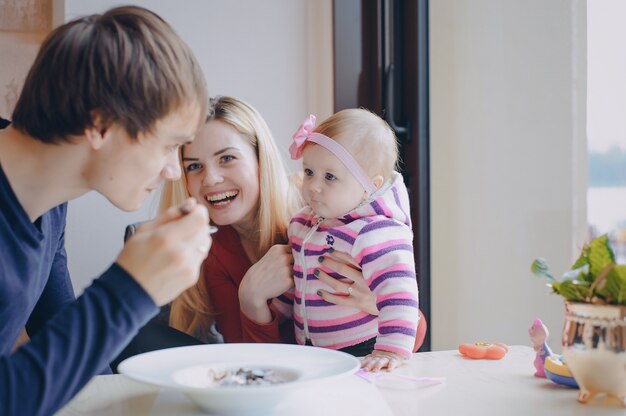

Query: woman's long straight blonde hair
160;96;302;336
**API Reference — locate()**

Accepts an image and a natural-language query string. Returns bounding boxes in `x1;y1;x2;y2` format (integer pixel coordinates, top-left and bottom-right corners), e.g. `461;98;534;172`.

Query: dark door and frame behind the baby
333;0;432;351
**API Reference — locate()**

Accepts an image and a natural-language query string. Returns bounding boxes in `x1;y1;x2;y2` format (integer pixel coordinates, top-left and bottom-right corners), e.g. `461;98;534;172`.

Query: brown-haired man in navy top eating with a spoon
0;7;211;415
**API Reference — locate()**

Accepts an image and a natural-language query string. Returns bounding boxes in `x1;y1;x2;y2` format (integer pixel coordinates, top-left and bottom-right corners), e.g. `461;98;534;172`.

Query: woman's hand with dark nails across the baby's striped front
317;251;378;316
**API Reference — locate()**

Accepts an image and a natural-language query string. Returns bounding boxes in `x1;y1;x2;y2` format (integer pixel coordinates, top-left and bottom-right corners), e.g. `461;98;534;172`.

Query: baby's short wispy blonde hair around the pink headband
315;108;398;180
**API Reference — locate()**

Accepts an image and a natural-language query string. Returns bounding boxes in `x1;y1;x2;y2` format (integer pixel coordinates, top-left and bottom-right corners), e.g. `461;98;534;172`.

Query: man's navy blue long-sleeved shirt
0;163;158;415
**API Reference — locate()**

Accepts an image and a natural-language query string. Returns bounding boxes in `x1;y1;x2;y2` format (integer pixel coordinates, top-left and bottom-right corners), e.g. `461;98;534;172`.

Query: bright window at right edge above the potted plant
587;0;626;263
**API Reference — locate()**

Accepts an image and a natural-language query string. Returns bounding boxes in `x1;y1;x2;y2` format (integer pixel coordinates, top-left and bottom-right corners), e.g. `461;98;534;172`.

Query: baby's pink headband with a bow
289;114;376;195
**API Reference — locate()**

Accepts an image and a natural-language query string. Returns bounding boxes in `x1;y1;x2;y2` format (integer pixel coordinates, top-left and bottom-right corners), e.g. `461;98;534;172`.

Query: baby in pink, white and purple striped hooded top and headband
273;109;419;370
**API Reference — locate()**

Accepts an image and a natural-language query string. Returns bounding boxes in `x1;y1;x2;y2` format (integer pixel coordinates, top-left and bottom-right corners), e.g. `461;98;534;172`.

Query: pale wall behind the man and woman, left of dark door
54;0;332;292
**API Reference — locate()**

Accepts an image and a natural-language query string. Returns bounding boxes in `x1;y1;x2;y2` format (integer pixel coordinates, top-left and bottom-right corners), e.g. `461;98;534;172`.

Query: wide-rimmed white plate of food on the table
118;344;360;414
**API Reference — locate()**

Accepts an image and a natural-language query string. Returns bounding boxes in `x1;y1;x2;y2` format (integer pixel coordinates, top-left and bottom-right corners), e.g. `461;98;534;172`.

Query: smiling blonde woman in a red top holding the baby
161;97;378;342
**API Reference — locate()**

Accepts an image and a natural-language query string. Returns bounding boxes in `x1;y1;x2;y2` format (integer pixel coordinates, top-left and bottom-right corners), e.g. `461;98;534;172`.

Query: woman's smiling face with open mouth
182;120;259;228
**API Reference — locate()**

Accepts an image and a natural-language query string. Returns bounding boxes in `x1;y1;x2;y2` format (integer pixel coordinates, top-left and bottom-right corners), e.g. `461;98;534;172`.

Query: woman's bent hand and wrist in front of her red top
239;244;293;324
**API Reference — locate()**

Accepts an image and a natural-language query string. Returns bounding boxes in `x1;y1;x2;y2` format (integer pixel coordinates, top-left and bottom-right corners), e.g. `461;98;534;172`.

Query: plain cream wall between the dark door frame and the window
430;0;587;352
